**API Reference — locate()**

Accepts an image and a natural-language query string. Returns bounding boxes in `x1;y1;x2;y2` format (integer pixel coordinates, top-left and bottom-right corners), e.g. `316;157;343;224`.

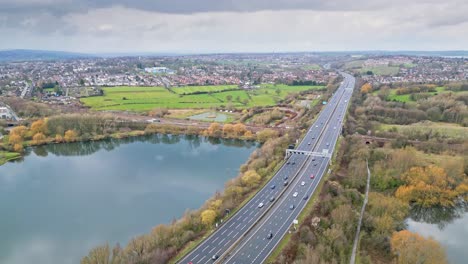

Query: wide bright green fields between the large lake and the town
80;84;323;112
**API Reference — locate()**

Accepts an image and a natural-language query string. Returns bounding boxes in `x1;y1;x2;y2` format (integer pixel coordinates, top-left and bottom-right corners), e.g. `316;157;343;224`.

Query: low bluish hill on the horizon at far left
0;49;95;62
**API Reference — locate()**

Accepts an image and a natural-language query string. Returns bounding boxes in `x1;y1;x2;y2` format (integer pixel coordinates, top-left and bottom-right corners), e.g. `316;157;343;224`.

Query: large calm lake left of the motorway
0;135;257;264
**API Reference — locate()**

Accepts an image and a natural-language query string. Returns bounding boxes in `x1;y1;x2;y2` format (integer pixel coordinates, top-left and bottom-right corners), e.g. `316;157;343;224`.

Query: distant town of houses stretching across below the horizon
0;53;468;111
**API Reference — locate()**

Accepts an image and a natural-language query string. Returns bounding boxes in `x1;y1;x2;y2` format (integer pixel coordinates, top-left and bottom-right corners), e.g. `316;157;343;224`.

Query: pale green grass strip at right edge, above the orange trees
380;121;468;140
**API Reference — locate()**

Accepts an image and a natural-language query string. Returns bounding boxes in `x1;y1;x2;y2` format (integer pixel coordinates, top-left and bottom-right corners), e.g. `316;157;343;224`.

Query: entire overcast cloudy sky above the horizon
0;0;468;53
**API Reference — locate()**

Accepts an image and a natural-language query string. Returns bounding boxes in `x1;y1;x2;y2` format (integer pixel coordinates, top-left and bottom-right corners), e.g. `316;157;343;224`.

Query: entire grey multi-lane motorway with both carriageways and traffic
179;73;354;263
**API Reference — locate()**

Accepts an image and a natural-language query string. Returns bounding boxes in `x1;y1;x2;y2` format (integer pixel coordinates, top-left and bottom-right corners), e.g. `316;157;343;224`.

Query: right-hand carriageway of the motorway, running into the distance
223;71;354;264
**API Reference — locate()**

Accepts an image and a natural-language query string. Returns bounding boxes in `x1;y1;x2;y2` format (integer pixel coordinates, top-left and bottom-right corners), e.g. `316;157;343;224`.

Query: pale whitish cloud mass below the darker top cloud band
0;0;468;52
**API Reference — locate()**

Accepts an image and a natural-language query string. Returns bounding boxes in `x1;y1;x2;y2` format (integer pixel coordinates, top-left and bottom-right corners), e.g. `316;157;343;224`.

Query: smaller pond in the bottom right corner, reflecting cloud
407;204;468;264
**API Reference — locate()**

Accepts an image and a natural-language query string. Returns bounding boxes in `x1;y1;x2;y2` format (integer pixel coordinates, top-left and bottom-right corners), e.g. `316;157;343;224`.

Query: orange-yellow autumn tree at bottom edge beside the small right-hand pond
390;230;448;264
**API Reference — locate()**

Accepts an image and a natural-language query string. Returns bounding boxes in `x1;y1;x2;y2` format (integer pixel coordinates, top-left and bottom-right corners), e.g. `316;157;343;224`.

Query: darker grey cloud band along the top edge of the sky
0;0;446;15
